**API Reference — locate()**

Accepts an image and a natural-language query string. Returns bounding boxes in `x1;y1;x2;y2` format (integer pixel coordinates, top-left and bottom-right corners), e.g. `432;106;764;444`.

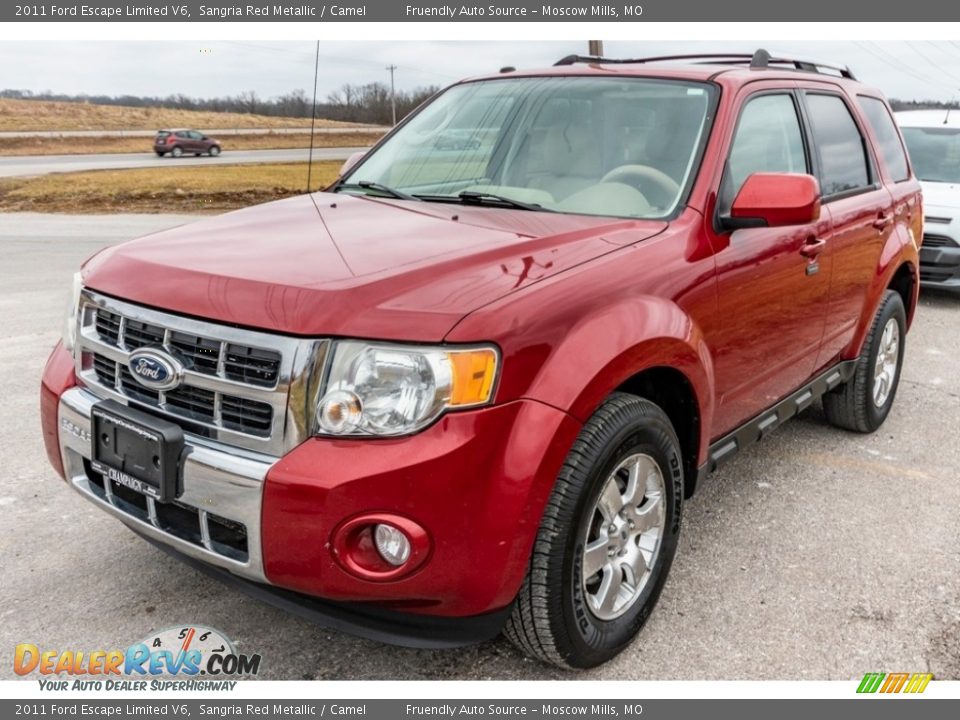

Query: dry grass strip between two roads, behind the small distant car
0;132;383;156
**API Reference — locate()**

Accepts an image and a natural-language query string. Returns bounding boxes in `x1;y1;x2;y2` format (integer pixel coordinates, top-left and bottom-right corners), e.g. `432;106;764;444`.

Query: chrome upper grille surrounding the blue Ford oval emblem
76;291;329;457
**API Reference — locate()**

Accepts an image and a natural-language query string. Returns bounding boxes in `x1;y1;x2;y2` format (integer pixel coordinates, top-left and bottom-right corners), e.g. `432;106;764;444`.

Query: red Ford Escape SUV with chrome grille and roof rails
42;51;923;668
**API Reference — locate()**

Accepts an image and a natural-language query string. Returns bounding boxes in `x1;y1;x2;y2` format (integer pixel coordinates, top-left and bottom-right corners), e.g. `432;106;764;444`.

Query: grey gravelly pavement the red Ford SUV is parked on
0;210;960;680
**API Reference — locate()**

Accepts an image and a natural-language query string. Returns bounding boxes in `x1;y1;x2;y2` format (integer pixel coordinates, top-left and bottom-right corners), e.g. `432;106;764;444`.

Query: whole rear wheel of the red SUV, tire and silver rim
823;290;907;433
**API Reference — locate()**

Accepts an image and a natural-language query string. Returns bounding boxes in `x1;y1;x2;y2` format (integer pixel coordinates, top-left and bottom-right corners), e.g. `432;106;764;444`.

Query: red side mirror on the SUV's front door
721;173;820;230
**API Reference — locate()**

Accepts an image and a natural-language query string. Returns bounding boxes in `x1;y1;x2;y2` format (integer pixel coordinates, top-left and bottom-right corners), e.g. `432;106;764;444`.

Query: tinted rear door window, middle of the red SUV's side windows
806;93;872;197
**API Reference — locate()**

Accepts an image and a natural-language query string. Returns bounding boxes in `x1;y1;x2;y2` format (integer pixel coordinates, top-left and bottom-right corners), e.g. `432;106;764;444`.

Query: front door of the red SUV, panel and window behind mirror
711;89;830;436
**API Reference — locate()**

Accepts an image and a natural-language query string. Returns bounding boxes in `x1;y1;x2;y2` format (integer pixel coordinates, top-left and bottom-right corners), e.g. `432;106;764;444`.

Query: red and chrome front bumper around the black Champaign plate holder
41;348;580;620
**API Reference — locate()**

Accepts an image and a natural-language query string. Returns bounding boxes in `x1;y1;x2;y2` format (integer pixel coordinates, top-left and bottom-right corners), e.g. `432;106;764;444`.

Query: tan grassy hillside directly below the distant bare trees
0;98;368;132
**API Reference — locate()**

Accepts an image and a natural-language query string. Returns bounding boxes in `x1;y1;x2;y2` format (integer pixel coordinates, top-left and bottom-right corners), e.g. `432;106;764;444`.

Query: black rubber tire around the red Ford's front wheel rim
504;393;683;668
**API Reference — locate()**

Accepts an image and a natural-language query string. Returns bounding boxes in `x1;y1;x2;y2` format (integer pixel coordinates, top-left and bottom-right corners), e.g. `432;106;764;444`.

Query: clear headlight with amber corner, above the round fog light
317;341;498;436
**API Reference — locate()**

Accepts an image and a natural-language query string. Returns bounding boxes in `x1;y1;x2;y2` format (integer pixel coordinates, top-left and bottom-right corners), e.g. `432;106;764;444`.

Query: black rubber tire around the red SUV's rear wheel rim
823;290;907;433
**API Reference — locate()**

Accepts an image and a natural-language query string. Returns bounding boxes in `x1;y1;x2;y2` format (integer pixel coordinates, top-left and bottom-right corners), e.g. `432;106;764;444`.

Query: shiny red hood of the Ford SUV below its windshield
84;193;667;342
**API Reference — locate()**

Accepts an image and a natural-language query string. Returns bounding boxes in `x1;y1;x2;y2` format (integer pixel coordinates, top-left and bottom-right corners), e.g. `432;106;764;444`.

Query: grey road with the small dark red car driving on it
0;147;366;177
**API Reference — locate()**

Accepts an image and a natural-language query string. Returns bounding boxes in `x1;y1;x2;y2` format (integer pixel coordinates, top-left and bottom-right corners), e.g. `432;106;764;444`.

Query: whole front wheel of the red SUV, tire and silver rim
505;393;683;668
